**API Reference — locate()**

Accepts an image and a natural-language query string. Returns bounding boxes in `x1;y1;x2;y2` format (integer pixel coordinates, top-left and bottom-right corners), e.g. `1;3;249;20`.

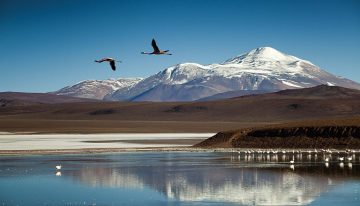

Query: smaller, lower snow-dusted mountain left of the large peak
53;78;142;99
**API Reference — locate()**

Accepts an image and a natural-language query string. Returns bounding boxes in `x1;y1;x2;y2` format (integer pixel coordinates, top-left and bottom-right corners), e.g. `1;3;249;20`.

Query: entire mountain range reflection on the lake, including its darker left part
66;159;354;205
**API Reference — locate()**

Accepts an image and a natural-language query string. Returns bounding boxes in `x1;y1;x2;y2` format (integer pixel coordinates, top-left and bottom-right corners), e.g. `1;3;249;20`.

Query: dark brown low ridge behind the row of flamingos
195;126;360;149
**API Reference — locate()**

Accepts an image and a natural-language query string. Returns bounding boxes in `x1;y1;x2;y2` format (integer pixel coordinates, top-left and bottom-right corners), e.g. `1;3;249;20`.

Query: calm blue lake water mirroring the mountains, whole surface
0;152;360;205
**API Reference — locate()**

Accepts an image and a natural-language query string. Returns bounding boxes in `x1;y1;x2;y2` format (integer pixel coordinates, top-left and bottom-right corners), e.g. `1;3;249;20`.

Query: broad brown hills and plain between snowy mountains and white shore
0;85;360;132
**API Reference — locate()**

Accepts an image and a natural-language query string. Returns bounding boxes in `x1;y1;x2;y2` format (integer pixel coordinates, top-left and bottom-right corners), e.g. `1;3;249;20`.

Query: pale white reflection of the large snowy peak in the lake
158;169;327;205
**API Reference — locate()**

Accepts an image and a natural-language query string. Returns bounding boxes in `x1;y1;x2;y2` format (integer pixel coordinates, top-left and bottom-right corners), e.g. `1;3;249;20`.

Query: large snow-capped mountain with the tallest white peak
104;47;360;101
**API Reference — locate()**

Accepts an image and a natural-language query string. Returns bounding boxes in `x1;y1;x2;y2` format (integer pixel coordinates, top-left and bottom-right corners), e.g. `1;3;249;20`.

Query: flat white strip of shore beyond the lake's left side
0;133;214;154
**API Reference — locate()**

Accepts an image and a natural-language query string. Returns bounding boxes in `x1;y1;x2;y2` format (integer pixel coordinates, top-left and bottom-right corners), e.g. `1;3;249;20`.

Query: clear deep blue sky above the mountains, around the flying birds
0;0;360;92
